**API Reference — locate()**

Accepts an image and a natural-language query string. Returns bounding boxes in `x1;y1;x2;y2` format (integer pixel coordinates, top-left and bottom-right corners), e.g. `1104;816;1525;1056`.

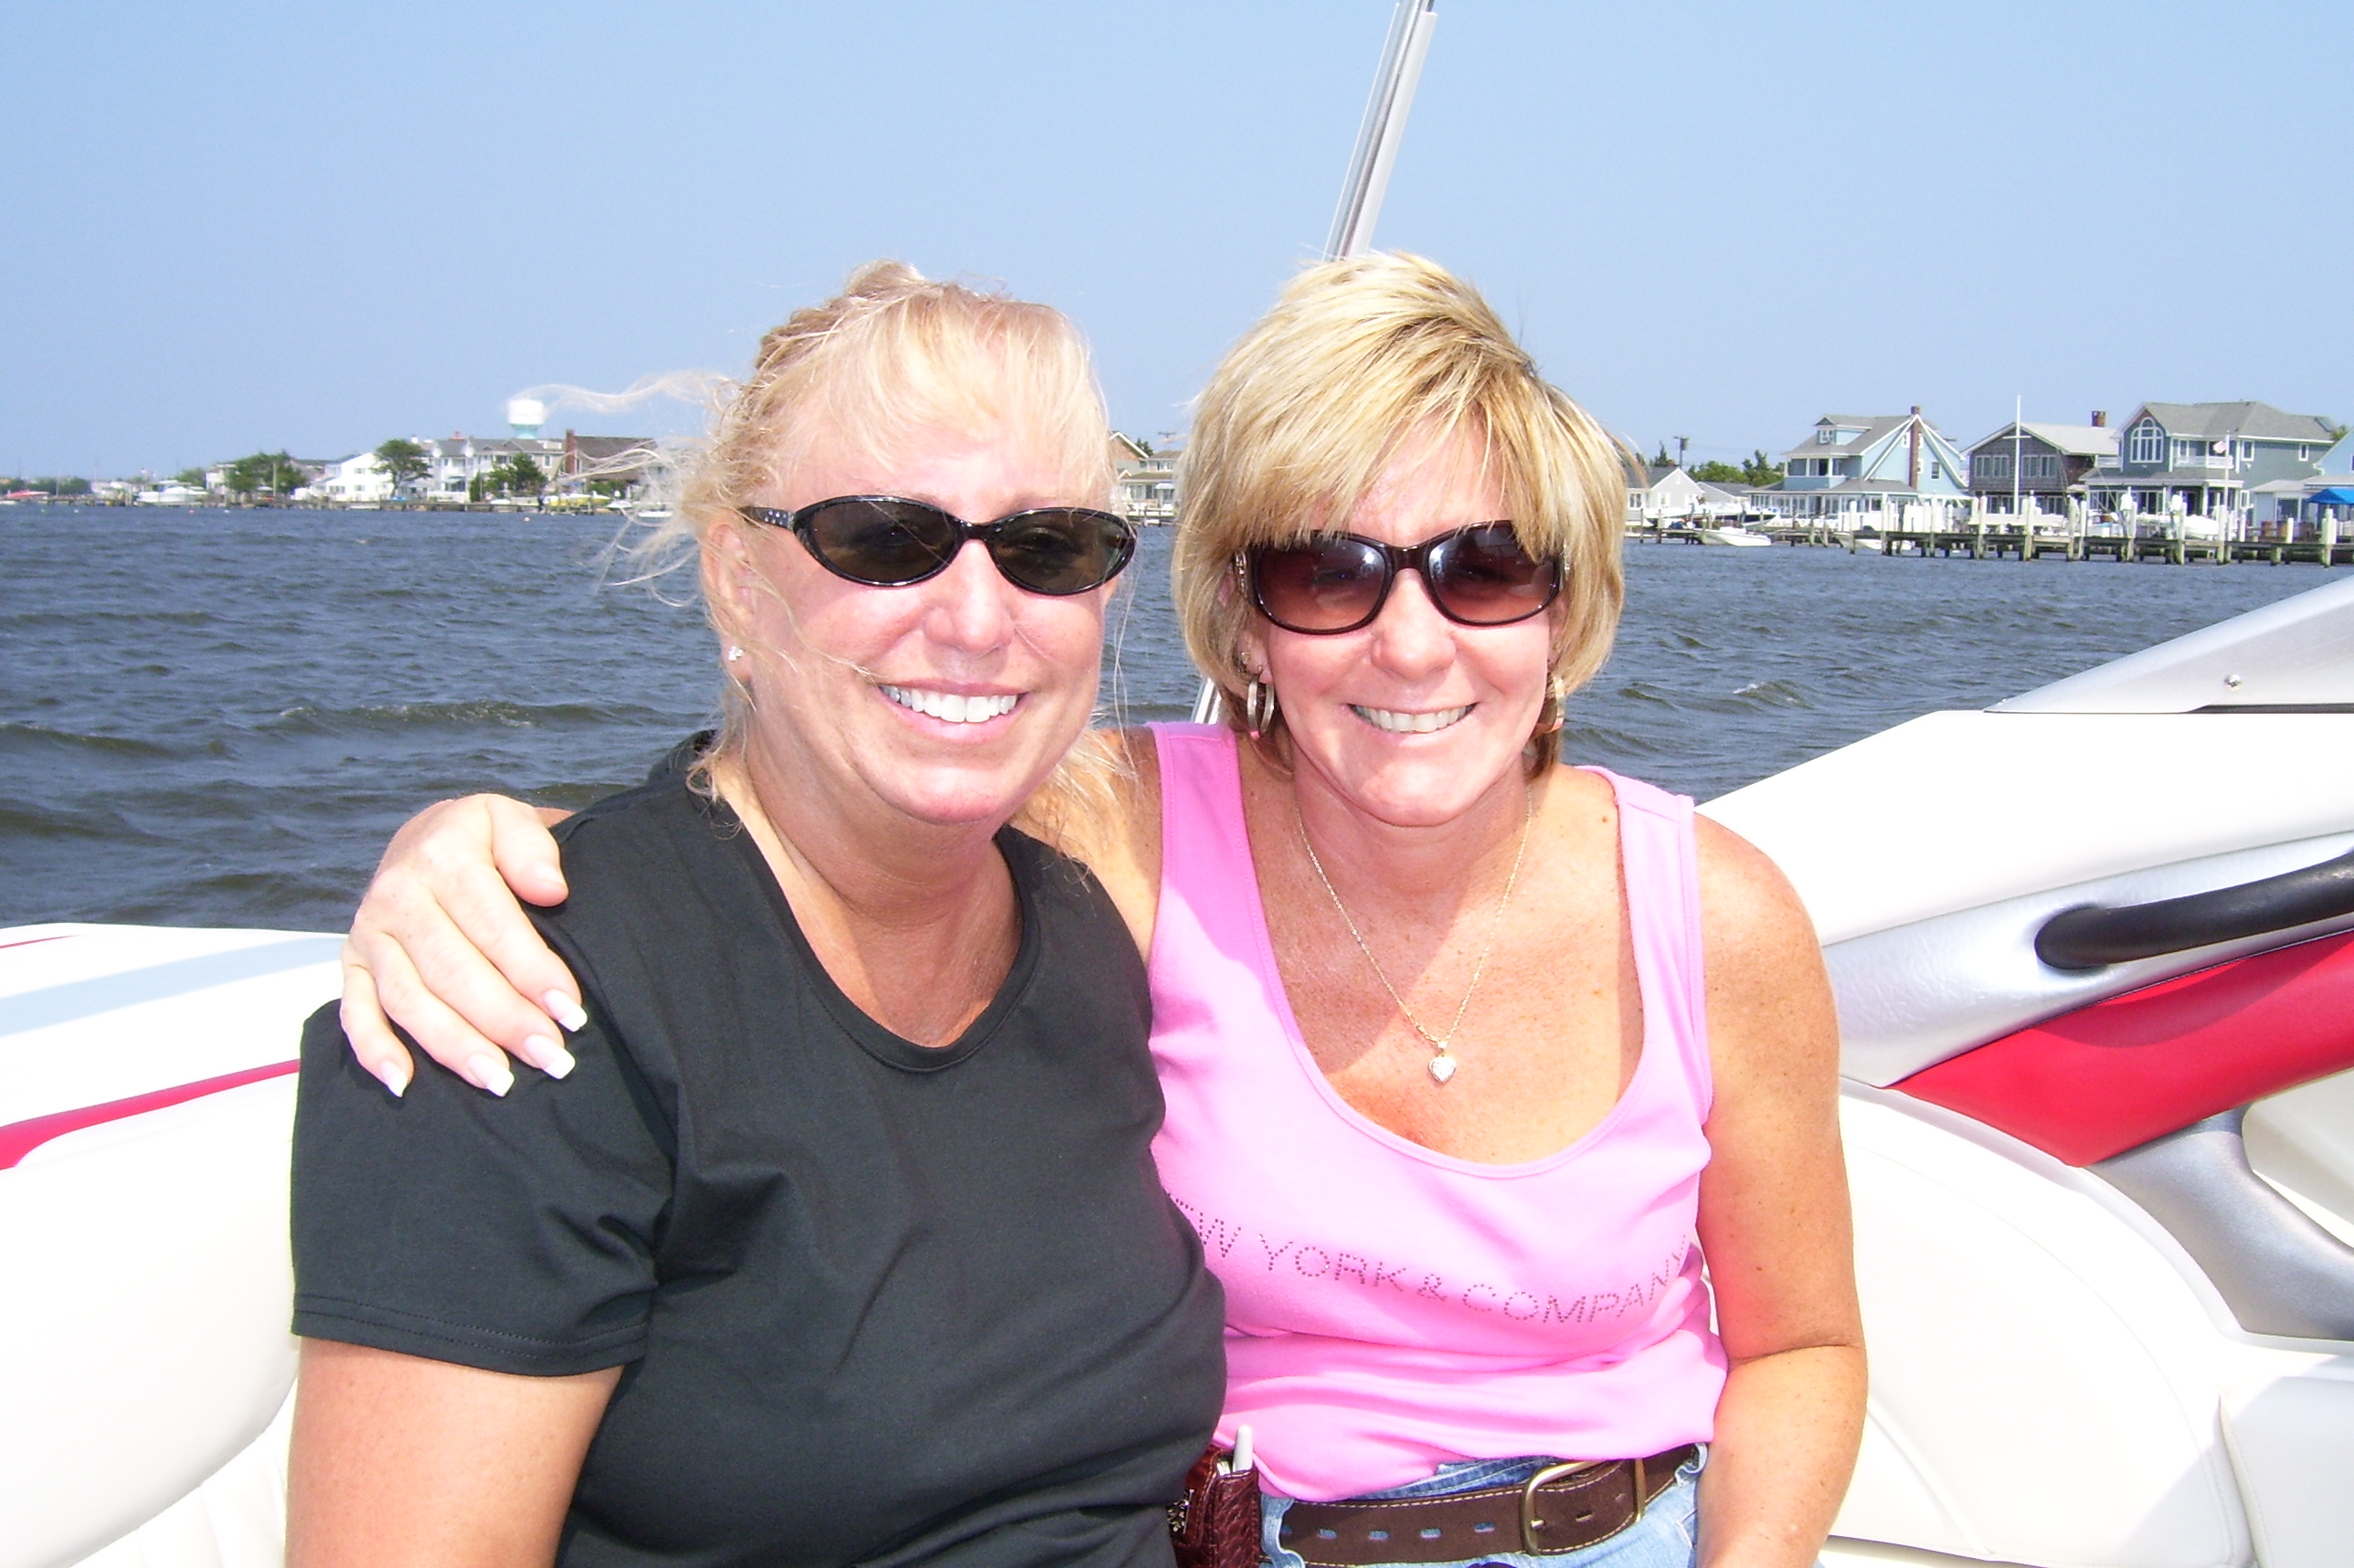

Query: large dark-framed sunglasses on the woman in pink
1243;523;1561;638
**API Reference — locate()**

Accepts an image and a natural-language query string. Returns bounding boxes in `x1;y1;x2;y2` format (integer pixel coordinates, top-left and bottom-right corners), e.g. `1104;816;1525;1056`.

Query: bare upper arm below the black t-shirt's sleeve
287;1340;621;1568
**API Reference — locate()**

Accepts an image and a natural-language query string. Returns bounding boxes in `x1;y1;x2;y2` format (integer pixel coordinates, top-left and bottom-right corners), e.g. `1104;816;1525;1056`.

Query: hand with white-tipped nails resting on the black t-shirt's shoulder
344;796;581;1095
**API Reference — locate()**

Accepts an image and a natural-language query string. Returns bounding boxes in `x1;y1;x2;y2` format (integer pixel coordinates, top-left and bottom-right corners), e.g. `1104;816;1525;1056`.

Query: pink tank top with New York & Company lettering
1151;726;1725;1502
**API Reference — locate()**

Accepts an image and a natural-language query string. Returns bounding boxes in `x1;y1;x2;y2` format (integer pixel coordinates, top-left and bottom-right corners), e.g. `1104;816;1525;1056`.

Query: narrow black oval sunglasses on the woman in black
737;494;1137;598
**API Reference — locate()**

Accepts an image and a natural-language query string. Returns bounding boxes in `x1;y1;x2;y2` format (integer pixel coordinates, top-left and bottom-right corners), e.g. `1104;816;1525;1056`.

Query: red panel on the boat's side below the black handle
1891;935;2354;1165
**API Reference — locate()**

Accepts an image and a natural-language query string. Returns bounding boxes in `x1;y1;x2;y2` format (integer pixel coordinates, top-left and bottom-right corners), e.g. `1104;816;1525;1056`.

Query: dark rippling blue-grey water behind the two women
0;506;2326;930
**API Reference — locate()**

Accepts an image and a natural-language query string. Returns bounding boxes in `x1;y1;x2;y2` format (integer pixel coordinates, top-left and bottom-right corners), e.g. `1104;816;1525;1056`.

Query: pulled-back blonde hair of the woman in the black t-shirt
633;261;1111;775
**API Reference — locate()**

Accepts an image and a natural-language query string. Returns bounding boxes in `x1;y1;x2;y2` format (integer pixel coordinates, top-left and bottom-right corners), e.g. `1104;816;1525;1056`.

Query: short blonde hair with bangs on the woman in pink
1174;254;1631;765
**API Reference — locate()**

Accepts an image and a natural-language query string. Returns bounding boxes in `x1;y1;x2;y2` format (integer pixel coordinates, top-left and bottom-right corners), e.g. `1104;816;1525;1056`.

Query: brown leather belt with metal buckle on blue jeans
1280;1443;1695;1568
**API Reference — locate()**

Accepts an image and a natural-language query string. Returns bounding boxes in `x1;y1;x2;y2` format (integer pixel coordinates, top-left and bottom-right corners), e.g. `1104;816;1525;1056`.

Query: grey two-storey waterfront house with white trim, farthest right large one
2084;403;2340;532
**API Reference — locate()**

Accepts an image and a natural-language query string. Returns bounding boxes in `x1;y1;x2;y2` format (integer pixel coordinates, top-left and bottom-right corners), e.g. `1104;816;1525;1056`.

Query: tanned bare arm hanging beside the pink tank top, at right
1700;820;1864;1568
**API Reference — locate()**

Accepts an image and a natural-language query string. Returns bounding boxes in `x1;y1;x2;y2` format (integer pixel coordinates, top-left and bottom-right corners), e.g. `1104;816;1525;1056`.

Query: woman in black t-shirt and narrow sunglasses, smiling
290;266;1222;1568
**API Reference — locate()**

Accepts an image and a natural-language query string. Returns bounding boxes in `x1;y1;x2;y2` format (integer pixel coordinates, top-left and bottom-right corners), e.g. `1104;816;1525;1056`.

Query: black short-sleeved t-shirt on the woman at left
294;768;1225;1568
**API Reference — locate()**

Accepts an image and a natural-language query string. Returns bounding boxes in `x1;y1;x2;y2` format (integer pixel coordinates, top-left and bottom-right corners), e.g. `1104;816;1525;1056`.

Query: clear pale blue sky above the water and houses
0;0;2354;473
